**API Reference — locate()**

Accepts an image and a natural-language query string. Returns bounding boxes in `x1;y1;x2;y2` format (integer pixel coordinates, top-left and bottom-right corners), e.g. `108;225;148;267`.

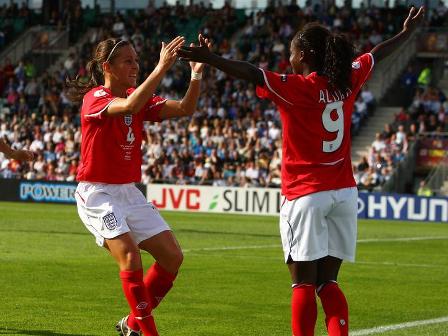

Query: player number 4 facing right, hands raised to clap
67;36;208;336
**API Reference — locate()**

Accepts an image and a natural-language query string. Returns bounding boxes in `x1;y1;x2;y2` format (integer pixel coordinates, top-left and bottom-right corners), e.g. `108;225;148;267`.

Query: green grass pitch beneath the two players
0;203;448;336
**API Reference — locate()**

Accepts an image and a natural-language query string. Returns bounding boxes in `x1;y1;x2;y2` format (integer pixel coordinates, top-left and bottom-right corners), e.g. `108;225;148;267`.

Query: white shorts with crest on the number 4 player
75;182;171;246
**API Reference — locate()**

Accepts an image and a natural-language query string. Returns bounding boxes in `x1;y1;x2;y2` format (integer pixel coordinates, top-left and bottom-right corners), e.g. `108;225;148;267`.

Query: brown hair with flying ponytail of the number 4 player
65;38;130;102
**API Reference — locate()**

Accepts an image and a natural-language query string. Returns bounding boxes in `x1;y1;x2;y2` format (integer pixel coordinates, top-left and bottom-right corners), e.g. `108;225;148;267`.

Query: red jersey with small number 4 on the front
76;86;166;184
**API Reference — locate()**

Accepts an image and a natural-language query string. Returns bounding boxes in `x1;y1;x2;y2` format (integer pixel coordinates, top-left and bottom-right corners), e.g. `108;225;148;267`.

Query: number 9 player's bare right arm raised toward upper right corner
371;7;425;64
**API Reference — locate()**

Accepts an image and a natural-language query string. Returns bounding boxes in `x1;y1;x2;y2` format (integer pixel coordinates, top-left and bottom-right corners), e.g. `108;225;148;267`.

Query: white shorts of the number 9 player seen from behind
280;187;358;262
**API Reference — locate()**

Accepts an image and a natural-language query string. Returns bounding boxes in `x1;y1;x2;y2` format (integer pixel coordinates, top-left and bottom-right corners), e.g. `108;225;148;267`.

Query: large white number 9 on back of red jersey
322;101;344;153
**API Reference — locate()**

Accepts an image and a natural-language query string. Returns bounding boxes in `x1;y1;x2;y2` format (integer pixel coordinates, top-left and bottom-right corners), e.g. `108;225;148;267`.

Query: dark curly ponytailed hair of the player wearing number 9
293;22;355;90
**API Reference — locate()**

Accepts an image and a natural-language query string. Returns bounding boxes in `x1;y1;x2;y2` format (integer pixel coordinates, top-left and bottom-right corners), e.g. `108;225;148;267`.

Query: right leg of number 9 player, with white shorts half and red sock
318;188;358;336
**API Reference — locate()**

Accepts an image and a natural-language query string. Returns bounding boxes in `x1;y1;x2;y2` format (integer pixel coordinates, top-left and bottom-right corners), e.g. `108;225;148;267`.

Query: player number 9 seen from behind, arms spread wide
178;8;424;336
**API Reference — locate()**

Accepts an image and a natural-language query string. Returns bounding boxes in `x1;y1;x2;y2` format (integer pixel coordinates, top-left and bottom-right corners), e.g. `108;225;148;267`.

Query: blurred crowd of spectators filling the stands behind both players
0;1;446;186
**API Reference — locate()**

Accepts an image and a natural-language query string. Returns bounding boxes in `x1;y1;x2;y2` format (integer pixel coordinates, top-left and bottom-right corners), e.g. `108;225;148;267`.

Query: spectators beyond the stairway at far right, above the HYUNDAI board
353;65;448;190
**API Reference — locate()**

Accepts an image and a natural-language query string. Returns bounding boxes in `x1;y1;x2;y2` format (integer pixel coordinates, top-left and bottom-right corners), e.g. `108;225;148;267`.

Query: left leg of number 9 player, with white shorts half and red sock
280;193;331;336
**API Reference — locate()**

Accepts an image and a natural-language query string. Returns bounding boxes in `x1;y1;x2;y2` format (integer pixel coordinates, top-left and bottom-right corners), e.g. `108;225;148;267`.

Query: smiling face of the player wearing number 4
110;45;140;88
